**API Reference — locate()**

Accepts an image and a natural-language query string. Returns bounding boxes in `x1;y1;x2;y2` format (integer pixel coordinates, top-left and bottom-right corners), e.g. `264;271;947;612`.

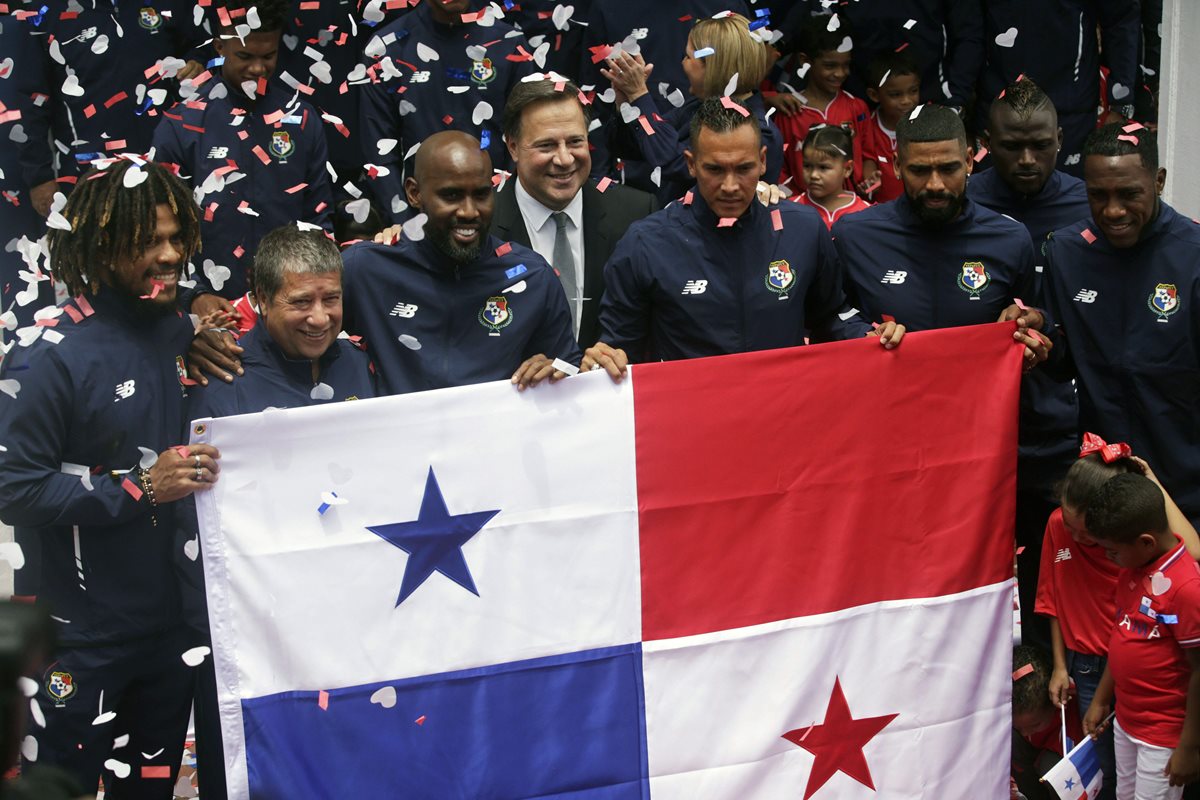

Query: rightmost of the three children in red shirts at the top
857;52;920;203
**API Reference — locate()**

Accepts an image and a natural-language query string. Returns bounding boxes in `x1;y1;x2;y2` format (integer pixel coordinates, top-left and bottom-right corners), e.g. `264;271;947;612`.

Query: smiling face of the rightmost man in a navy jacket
1084;154;1166;248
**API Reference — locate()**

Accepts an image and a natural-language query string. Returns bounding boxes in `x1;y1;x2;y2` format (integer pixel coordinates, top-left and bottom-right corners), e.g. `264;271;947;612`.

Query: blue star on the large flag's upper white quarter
367;467;500;607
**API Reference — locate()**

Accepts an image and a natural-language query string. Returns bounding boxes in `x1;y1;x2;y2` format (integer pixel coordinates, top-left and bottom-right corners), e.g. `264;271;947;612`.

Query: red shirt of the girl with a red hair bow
1033;509;1121;656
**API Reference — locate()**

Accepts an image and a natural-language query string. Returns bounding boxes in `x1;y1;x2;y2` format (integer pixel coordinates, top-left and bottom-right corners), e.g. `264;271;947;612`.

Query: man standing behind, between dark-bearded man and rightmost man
967;78;1088;657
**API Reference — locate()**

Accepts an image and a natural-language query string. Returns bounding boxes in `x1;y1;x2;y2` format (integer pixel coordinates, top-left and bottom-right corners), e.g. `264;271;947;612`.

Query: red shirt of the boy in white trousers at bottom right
1109;540;1200;747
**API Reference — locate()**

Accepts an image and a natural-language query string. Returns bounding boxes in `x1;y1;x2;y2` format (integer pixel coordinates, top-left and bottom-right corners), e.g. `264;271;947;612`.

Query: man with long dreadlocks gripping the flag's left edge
0;156;218;800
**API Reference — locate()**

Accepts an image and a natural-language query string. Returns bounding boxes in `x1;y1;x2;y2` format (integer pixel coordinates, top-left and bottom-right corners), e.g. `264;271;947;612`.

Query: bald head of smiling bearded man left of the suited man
404;134;496;264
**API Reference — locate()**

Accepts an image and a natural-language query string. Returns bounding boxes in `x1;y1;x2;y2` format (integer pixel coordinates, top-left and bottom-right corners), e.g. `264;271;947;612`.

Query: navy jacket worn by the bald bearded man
342;236;582;395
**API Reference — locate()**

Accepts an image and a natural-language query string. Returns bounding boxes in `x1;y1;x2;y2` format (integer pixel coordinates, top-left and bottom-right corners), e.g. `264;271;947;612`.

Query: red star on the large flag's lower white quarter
784;678;899;800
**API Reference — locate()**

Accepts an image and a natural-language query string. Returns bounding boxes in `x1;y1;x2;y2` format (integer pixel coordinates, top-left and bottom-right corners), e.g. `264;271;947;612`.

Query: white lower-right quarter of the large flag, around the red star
643;582;1013;800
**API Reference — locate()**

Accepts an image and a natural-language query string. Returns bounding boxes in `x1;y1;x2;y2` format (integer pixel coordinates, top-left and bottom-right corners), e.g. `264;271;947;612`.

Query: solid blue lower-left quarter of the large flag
242;644;649;800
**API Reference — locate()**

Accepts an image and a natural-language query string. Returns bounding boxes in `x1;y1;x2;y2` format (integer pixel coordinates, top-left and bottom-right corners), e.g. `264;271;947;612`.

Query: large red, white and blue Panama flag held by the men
193;324;1021;800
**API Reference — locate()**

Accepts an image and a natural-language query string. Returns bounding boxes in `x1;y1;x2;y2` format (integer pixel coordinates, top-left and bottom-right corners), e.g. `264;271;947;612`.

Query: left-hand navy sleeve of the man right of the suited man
600;233;653;361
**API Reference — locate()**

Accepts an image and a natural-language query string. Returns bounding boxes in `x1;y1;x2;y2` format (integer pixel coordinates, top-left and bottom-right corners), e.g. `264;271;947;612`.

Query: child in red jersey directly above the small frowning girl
775;14;868;193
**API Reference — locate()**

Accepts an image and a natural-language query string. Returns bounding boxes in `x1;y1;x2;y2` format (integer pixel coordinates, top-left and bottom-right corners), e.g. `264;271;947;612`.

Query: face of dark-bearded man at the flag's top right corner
895;139;971;227
